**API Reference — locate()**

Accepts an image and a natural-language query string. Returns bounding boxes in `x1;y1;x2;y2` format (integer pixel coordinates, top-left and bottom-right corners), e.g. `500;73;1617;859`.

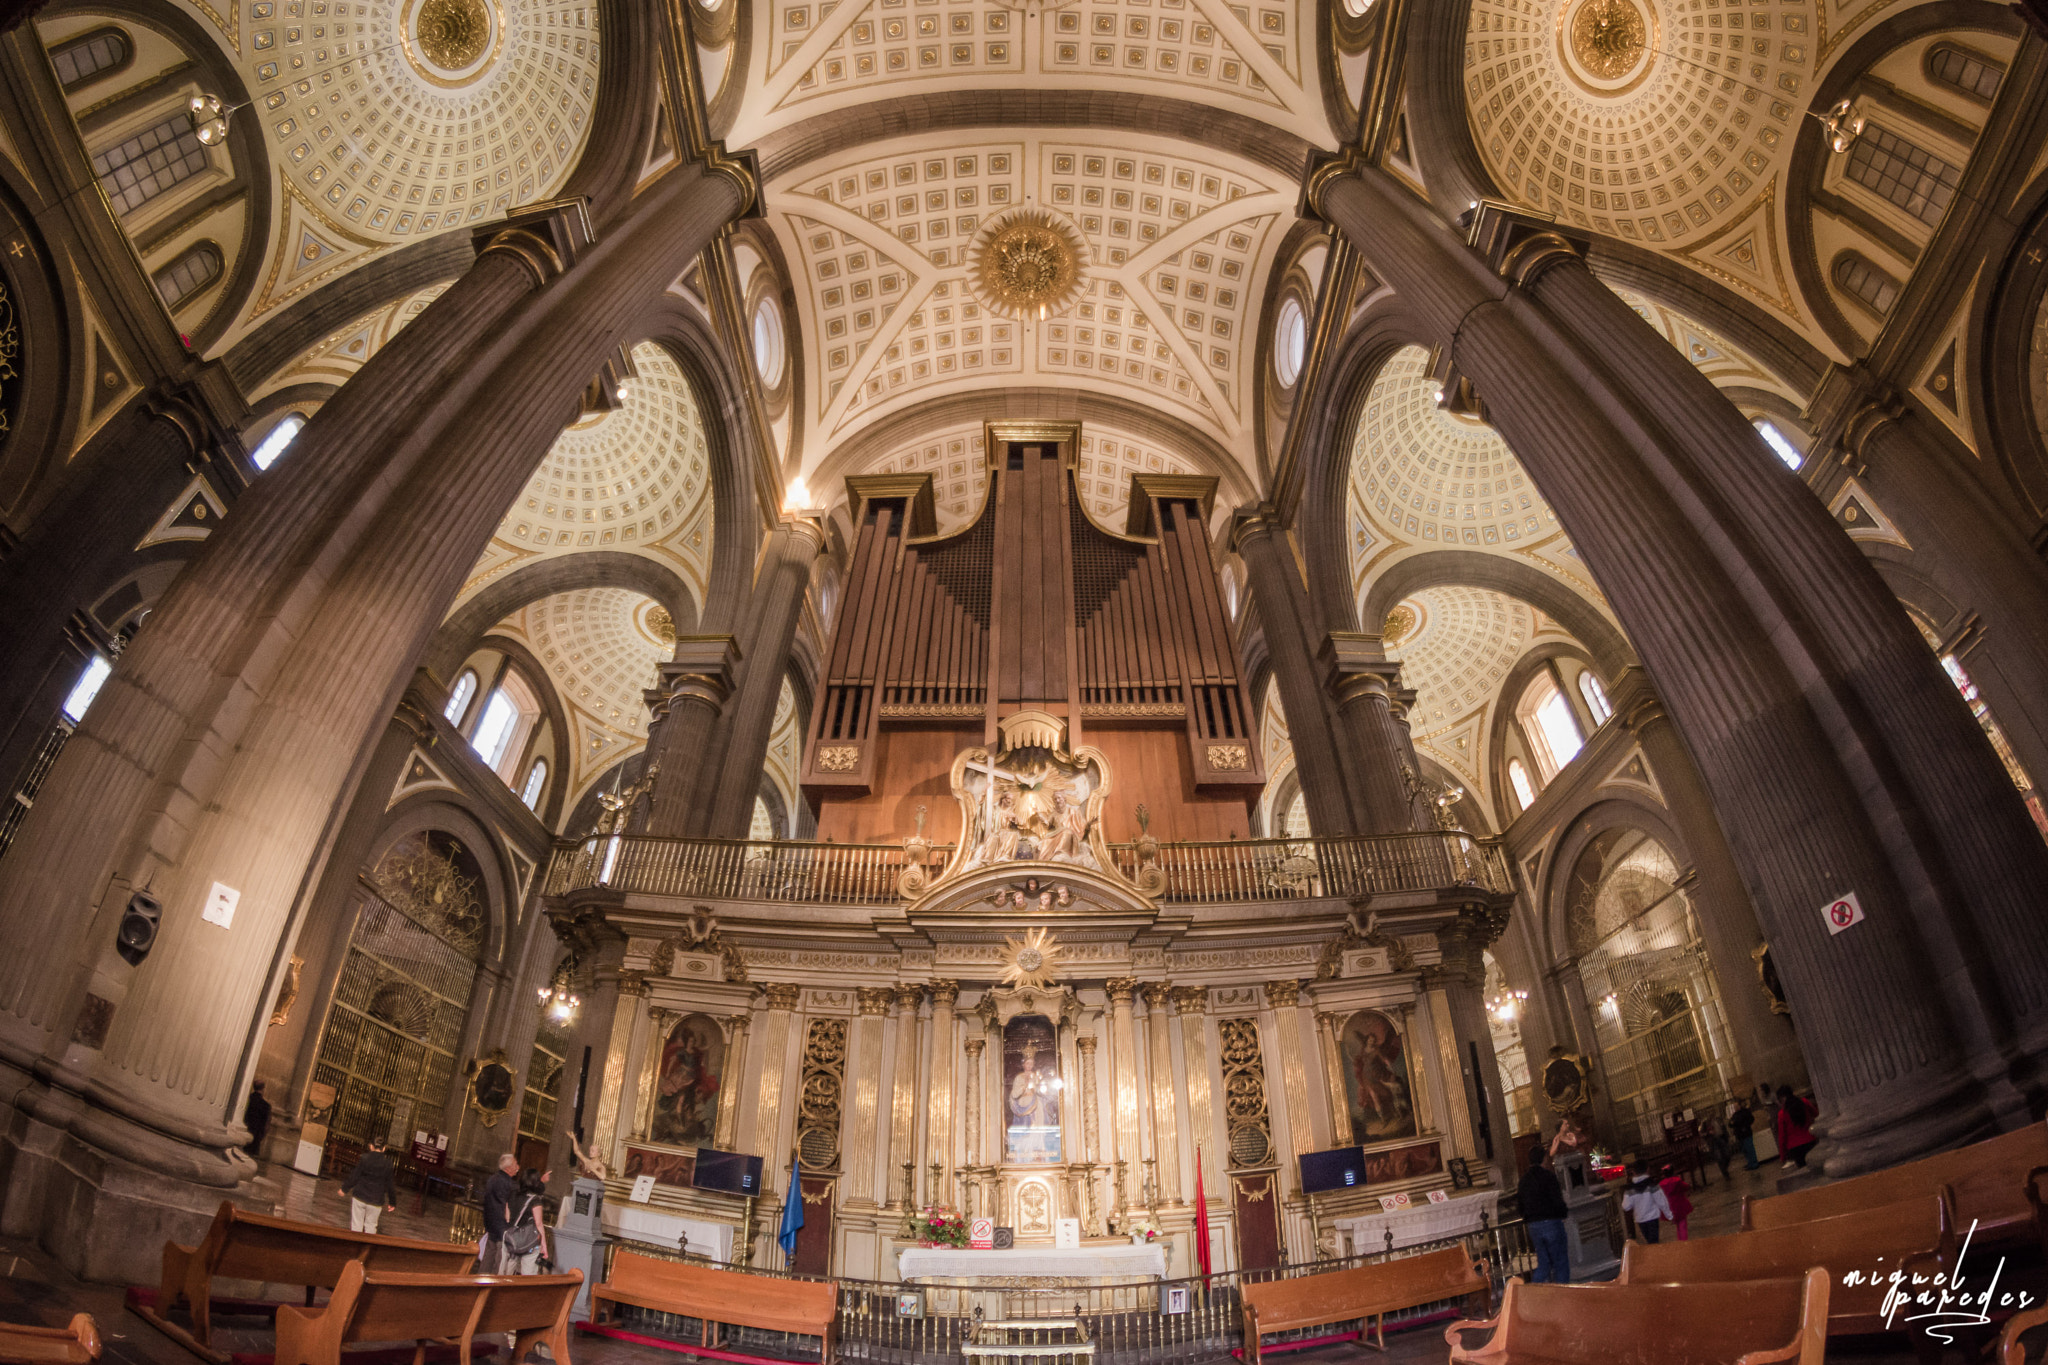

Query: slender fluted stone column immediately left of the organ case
690;516;825;839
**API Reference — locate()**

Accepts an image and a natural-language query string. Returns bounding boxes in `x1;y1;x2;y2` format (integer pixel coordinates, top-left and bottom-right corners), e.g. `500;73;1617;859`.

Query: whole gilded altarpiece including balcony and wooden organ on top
549;424;1509;1279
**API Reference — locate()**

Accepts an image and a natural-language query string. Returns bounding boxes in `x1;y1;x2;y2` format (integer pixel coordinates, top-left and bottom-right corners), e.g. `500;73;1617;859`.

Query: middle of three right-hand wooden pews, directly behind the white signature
1616;1185;1958;1347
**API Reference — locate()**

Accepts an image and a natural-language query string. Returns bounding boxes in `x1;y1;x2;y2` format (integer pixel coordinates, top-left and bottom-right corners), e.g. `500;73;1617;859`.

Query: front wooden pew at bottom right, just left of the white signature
1444;1277;1827;1365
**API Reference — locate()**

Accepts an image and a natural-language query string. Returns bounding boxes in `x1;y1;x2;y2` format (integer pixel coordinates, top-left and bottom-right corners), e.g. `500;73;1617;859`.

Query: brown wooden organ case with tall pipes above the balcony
801;422;1266;843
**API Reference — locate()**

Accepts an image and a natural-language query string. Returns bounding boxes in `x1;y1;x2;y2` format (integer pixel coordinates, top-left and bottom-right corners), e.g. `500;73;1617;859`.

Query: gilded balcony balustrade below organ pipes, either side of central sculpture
545;829;1513;905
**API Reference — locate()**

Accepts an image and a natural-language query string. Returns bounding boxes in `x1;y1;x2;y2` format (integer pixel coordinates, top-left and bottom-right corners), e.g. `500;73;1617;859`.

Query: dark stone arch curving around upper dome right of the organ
1294;294;1441;630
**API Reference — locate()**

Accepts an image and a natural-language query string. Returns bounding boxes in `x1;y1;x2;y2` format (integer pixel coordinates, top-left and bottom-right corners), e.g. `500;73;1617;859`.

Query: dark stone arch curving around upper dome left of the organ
639;293;774;634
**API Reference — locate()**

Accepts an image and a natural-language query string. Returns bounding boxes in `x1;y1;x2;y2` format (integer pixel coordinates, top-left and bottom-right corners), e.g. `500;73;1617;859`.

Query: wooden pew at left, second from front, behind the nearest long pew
135;1199;475;1363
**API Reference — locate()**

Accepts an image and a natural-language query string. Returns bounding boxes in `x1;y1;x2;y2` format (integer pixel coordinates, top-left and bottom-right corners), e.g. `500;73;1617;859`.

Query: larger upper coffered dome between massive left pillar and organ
459;344;711;606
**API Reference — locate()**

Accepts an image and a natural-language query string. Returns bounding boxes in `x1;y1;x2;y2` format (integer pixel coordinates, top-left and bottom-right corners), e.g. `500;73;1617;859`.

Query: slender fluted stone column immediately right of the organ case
1231;508;1360;835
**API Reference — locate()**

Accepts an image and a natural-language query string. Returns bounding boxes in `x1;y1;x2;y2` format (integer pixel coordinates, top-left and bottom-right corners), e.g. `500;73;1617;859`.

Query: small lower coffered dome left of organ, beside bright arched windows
498;587;676;806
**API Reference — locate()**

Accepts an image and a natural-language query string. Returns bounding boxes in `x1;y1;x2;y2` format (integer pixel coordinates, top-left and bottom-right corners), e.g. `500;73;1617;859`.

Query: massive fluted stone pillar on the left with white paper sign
0;144;752;1275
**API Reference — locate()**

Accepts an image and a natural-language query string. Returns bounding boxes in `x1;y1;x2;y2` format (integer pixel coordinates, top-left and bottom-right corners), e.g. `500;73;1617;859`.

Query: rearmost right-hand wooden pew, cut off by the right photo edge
1743;1121;2048;1248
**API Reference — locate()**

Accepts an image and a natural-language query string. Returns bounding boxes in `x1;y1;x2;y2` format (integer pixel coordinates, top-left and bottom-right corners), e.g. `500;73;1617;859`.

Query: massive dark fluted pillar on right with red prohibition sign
1311;164;2048;1175
